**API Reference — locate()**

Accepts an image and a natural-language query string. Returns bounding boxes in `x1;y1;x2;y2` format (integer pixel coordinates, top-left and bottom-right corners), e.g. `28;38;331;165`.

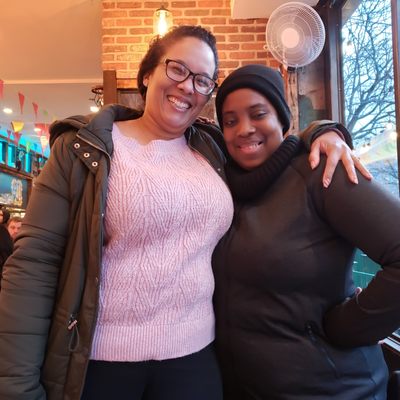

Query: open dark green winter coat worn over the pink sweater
0;105;225;400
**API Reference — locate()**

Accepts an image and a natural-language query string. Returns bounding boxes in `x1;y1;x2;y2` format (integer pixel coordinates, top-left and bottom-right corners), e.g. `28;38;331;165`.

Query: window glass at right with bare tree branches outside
341;0;400;333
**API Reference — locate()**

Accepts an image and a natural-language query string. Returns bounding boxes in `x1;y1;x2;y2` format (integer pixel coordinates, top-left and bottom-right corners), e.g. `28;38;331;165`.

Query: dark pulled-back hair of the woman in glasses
137;25;219;101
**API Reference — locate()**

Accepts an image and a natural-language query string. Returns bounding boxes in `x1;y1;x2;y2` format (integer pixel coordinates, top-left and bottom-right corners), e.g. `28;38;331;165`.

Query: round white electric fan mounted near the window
265;2;325;69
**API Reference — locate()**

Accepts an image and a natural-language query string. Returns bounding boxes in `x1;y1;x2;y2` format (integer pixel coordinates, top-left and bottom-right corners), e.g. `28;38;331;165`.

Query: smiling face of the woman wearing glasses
143;37;216;138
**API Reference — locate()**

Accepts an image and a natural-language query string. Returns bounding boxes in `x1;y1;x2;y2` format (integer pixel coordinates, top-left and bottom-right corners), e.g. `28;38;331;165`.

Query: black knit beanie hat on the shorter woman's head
215;64;290;133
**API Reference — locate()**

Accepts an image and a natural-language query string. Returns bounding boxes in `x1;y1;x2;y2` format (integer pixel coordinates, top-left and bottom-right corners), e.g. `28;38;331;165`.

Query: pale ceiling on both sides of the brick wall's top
0;0;318;152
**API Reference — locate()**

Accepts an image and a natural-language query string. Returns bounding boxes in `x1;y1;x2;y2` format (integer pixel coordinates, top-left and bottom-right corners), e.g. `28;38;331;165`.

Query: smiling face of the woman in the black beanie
222;89;283;170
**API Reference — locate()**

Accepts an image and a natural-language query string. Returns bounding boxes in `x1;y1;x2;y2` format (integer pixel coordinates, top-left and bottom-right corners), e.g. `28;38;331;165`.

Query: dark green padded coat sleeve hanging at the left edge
0;137;71;400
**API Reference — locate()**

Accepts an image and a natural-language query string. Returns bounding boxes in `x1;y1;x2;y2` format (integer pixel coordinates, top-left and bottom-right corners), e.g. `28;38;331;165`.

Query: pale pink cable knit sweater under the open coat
91;125;233;361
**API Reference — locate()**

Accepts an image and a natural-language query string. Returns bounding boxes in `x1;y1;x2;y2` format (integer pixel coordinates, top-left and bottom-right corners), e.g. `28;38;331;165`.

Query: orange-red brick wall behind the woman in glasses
102;0;279;88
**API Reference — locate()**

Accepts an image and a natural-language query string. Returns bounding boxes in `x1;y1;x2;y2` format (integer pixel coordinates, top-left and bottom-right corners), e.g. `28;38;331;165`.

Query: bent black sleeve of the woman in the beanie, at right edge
313;159;400;346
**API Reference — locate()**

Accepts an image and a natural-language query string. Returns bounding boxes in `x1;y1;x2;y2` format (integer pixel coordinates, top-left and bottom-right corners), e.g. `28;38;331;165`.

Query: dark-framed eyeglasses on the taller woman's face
165;58;218;96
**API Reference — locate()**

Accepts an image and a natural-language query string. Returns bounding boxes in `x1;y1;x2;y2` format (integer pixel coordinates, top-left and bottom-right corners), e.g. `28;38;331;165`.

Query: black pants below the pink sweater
81;345;222;400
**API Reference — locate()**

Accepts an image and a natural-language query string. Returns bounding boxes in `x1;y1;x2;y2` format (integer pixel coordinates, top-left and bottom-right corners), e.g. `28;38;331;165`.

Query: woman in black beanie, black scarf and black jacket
213;65;400;400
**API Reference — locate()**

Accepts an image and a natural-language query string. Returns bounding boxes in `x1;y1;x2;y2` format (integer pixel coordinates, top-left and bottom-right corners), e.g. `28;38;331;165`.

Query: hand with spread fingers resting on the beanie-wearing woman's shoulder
309;131;372;188
